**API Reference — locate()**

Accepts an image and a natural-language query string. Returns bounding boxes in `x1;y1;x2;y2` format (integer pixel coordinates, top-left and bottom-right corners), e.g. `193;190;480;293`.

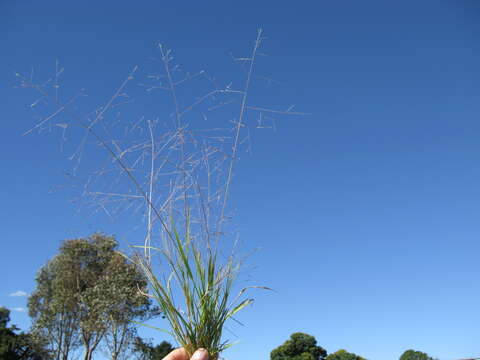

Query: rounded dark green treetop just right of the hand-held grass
270;333;327;360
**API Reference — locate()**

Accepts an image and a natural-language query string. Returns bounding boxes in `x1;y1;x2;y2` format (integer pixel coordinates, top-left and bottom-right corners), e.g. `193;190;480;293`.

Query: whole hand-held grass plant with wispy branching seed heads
17;30;303;360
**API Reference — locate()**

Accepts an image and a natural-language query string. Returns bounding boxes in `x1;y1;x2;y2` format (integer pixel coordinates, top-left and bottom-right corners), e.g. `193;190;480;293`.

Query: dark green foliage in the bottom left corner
0;307;51;360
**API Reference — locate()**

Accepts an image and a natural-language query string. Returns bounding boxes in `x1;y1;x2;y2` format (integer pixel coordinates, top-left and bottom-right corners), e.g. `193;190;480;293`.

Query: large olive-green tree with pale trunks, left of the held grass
28;234;150;360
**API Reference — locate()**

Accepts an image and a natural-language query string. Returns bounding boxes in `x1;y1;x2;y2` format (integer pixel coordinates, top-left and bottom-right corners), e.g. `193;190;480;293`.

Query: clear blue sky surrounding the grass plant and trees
0;0;480;360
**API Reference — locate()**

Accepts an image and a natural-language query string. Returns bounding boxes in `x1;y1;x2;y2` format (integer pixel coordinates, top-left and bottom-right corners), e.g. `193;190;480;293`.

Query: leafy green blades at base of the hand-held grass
134;218;260;360
